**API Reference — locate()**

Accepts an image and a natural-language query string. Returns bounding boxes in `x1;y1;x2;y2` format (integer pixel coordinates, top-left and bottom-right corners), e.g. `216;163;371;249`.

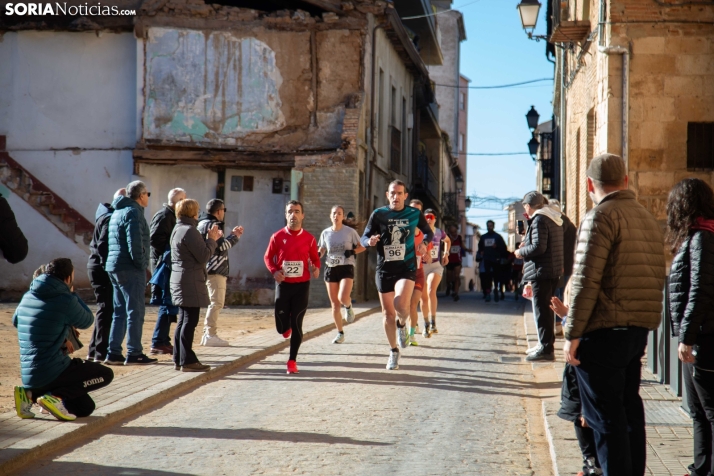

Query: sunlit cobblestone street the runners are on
25;294;551;475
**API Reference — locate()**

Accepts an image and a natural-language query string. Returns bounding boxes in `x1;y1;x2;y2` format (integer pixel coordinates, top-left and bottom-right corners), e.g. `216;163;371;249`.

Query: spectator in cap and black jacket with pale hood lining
515;191;563;361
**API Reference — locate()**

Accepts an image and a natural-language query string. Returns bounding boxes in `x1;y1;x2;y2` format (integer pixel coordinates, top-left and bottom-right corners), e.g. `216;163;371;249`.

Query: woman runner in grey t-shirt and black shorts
317;205;365;344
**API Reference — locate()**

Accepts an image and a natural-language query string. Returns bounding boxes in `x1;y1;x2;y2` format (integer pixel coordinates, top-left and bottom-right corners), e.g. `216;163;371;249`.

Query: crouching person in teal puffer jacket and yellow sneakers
12;258;114;421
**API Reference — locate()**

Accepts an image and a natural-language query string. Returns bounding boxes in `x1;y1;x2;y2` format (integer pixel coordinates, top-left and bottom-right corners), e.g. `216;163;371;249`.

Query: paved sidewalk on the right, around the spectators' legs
523;310;693;476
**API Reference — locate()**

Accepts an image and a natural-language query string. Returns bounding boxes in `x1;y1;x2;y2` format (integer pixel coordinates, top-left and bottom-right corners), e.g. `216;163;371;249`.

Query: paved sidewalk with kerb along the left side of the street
0;303;380;474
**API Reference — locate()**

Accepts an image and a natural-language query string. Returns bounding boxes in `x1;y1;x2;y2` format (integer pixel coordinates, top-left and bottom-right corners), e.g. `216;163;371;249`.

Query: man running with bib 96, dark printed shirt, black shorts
362;180;433;370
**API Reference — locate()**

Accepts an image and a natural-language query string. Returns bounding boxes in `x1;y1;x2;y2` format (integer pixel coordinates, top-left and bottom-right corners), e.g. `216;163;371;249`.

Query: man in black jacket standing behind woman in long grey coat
149;188;186;354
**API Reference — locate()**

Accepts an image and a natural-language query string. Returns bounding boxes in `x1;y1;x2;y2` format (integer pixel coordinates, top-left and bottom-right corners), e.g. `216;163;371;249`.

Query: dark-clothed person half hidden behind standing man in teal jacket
87;188;126;362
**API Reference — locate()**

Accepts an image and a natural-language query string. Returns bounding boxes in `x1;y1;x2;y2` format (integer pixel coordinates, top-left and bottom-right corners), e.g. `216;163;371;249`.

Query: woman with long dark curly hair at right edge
667;178;714;475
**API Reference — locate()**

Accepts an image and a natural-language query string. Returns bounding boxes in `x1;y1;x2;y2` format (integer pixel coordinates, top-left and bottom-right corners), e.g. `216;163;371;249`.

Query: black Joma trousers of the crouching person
28;359;114;417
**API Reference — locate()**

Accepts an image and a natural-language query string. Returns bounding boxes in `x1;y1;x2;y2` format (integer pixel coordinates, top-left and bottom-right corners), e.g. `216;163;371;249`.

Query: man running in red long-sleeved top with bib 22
263;200;320;374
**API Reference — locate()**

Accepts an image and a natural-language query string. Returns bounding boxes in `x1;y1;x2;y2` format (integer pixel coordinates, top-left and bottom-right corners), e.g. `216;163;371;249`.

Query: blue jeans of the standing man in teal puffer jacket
109;269;146;356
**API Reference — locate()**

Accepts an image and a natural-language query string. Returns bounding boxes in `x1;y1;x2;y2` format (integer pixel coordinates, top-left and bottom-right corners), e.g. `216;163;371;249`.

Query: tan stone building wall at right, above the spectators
565;0;714;226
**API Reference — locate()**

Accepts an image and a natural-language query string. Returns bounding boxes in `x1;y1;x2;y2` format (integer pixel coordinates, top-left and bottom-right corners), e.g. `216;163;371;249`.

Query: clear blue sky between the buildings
452;0;553;238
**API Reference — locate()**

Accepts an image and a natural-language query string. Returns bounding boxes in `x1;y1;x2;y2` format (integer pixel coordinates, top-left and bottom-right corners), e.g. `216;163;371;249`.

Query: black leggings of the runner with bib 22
275;281;310;360
